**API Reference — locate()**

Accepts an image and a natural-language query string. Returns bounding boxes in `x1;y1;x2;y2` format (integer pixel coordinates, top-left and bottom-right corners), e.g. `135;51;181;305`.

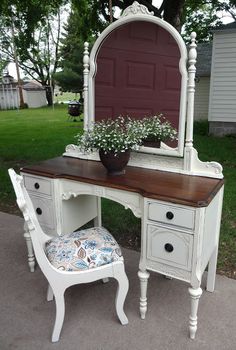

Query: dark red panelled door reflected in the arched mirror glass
95;21;181;149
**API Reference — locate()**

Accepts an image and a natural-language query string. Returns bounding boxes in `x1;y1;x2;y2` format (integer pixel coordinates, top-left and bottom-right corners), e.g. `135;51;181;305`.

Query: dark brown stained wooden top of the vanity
21;157;224;207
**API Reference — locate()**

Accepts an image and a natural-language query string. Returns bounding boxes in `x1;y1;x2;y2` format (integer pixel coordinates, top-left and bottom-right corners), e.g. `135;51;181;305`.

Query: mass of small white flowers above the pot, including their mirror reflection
76;114;177;154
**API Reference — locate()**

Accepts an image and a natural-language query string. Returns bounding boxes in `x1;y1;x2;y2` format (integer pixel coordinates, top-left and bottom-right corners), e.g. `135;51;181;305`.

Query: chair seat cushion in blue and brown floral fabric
45;227;123;271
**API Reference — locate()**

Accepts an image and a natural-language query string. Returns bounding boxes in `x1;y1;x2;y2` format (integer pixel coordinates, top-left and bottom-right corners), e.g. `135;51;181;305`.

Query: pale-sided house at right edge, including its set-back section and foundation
194;22;236;136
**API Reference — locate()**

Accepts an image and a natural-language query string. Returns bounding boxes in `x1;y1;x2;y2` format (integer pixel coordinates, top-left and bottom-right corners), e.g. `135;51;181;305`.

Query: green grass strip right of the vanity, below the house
194;129;236;278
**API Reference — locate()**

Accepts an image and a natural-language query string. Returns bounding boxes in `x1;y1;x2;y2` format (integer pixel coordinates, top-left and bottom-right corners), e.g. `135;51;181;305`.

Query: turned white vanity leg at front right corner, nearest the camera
188;287;202;339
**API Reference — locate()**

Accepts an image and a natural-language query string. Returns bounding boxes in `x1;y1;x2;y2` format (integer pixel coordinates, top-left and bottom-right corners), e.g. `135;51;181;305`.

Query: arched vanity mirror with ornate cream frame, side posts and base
64;1;222;177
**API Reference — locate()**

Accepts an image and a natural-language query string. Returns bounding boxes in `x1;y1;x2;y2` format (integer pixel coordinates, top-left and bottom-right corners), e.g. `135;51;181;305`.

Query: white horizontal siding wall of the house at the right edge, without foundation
209;31;236;123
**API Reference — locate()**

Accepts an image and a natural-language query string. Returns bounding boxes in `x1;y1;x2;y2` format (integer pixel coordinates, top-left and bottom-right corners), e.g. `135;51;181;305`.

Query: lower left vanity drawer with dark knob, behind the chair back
30;195;55;229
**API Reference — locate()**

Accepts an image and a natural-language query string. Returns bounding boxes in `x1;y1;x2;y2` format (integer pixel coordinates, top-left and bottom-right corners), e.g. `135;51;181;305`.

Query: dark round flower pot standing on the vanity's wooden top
99;149;130;175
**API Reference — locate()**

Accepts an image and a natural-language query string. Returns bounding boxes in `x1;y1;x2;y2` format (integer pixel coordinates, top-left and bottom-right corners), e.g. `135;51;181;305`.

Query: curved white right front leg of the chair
114;266;129;325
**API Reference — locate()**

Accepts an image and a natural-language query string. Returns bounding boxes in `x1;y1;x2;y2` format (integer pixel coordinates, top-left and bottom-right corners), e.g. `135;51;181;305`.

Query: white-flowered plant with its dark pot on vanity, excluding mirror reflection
76;116;145;175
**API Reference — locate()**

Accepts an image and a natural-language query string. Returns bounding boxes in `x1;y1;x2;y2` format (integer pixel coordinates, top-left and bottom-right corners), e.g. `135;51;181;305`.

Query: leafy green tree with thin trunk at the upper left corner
0;0;65;105
